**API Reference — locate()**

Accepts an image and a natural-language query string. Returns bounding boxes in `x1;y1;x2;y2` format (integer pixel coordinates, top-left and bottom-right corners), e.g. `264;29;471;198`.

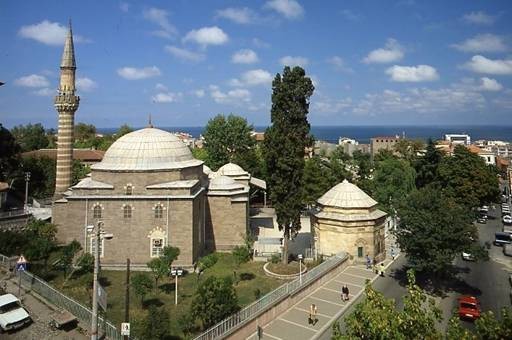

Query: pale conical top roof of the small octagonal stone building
318;180;377;209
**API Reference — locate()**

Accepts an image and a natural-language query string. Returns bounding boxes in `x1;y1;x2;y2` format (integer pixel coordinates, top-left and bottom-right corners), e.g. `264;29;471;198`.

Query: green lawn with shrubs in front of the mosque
36;253;284;337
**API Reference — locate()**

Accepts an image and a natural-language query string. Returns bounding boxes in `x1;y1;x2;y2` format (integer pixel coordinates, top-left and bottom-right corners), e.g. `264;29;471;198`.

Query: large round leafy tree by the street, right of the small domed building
396;187;485;274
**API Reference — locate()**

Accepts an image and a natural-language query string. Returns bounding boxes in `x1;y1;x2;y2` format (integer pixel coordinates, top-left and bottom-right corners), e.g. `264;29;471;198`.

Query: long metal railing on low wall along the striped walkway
194;253;348;340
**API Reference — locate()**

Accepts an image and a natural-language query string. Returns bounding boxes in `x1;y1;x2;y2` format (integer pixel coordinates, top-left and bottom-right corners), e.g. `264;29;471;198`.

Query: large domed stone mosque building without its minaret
53;127;250;267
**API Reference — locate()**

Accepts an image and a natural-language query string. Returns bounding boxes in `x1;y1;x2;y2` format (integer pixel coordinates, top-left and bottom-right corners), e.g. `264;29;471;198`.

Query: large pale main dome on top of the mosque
91;128;203;171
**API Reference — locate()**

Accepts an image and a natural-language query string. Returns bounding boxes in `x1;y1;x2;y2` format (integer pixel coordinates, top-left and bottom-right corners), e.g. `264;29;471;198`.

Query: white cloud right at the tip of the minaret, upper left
18;20;89;46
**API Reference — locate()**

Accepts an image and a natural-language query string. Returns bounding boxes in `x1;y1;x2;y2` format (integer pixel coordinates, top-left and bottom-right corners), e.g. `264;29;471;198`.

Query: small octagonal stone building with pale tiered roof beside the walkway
311;180;386;261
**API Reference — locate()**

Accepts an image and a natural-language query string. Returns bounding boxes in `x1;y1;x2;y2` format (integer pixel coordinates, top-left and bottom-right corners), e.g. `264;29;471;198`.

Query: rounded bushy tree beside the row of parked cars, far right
439;145;500;209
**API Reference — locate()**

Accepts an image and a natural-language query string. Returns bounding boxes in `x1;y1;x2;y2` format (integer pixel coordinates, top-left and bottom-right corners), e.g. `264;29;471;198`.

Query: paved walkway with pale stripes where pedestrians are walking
248;259;391;340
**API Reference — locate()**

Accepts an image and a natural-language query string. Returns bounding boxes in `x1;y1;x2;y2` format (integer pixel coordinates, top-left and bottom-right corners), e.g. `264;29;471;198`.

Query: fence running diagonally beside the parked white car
0;254;123;340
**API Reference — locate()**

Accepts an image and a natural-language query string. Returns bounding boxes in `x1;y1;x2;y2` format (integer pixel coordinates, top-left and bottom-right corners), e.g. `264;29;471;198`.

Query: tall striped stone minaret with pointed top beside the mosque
55;21;80;196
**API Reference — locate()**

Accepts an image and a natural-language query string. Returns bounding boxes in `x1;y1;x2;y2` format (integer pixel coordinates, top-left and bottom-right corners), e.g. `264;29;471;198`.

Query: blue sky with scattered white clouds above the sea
0;0;512;128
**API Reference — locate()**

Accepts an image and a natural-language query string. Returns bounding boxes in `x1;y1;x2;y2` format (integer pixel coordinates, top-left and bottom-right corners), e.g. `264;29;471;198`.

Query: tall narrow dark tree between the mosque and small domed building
263;66;315;263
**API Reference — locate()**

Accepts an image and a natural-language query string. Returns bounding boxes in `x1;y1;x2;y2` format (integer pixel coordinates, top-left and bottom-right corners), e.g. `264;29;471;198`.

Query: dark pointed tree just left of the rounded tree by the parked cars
413;139;444;189
